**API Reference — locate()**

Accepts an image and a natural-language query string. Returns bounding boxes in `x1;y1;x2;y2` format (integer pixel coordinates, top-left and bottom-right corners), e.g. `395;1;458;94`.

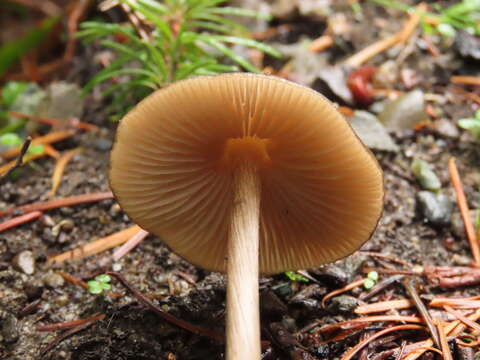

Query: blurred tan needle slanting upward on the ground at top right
345;4;426;67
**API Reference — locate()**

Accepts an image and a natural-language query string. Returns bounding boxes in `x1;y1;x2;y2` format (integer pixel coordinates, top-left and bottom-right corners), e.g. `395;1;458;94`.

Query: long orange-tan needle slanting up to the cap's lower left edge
47;225;141;265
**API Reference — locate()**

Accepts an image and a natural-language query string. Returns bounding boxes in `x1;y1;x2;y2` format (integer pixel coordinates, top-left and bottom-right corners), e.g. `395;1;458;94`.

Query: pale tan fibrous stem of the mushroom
226;161;261;360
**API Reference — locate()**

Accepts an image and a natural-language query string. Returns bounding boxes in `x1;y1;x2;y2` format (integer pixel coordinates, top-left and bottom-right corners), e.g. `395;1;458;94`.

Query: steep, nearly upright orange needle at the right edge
448;157;480;266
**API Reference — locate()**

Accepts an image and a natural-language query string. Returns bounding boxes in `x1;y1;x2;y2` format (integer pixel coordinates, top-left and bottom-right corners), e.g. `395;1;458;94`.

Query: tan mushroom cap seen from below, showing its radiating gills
110;73;383;273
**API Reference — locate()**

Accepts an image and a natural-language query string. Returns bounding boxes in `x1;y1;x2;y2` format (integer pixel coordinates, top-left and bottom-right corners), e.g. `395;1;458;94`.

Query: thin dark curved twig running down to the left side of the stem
108;272;225;341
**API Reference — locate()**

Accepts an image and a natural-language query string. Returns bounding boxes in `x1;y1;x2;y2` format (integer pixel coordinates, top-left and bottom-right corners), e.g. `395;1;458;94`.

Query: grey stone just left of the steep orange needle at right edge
417;191;453;226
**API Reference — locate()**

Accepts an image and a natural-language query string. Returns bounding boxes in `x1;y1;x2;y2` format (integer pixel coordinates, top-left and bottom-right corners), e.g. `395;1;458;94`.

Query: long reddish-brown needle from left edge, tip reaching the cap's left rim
0;191;113;217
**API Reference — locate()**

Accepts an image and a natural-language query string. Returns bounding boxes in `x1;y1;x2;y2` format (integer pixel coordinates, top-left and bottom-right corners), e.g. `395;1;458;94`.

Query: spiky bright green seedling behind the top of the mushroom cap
77;0;280;116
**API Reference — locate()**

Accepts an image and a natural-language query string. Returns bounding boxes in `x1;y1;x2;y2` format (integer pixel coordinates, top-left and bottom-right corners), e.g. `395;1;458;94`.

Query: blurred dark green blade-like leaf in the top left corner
0;17;60;75
